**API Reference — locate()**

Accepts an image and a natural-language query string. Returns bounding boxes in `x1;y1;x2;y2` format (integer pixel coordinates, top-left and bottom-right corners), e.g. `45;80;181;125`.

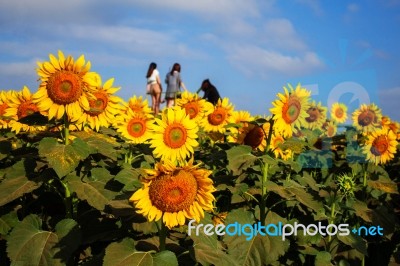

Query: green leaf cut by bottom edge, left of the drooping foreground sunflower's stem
103;238;153;266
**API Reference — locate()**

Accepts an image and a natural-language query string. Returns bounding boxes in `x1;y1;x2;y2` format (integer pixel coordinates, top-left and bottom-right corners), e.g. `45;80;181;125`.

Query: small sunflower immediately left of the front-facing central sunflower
116;110;154;144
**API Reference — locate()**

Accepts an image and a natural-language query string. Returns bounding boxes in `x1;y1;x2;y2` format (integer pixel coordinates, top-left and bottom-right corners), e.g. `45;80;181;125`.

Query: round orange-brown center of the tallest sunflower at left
46;71;83;105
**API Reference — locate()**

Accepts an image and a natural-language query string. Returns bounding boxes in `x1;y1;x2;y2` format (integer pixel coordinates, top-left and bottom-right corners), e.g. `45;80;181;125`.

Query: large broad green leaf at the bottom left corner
7;214;80;266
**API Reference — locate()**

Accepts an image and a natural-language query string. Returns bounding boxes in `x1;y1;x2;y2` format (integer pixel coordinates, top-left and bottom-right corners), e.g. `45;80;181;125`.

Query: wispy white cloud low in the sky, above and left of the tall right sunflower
227;45;323;77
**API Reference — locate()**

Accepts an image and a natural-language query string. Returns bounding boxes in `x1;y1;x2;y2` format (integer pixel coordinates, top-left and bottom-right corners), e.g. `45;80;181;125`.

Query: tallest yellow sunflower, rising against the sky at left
33;51;97;121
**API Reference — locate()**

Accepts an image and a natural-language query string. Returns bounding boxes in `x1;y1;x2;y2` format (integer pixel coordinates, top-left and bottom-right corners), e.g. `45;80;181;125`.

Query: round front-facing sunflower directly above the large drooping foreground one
150;106;199;161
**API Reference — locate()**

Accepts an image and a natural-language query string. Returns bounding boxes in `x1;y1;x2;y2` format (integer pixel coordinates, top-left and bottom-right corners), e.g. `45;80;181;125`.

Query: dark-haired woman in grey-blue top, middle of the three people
165;63;187;107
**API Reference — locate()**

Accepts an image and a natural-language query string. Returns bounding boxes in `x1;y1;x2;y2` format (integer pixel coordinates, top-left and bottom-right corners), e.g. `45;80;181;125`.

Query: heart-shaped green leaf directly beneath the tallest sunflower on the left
38;138;90;178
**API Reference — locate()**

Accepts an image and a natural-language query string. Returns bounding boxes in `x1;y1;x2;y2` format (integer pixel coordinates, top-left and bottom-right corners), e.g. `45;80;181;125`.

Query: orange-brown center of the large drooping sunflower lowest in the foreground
149;170;197;212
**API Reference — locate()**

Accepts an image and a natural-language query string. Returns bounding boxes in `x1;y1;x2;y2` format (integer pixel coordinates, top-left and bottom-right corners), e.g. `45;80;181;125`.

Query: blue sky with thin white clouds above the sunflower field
0;0;400;121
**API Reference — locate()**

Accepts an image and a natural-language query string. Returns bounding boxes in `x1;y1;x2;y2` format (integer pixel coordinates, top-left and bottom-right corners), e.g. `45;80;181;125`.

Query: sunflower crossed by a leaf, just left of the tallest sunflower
5;86;46;134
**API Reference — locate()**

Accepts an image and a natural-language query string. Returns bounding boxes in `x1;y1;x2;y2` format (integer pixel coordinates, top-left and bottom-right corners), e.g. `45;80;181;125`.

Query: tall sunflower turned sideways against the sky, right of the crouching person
270;84;311;137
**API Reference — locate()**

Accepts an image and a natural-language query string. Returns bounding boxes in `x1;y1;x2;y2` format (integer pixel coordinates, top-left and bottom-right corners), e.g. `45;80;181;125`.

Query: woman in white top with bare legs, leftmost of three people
146;62;162;115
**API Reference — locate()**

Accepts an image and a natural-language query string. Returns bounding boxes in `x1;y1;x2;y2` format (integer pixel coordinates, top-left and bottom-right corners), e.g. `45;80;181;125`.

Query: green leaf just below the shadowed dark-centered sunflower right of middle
226;145;257;175
